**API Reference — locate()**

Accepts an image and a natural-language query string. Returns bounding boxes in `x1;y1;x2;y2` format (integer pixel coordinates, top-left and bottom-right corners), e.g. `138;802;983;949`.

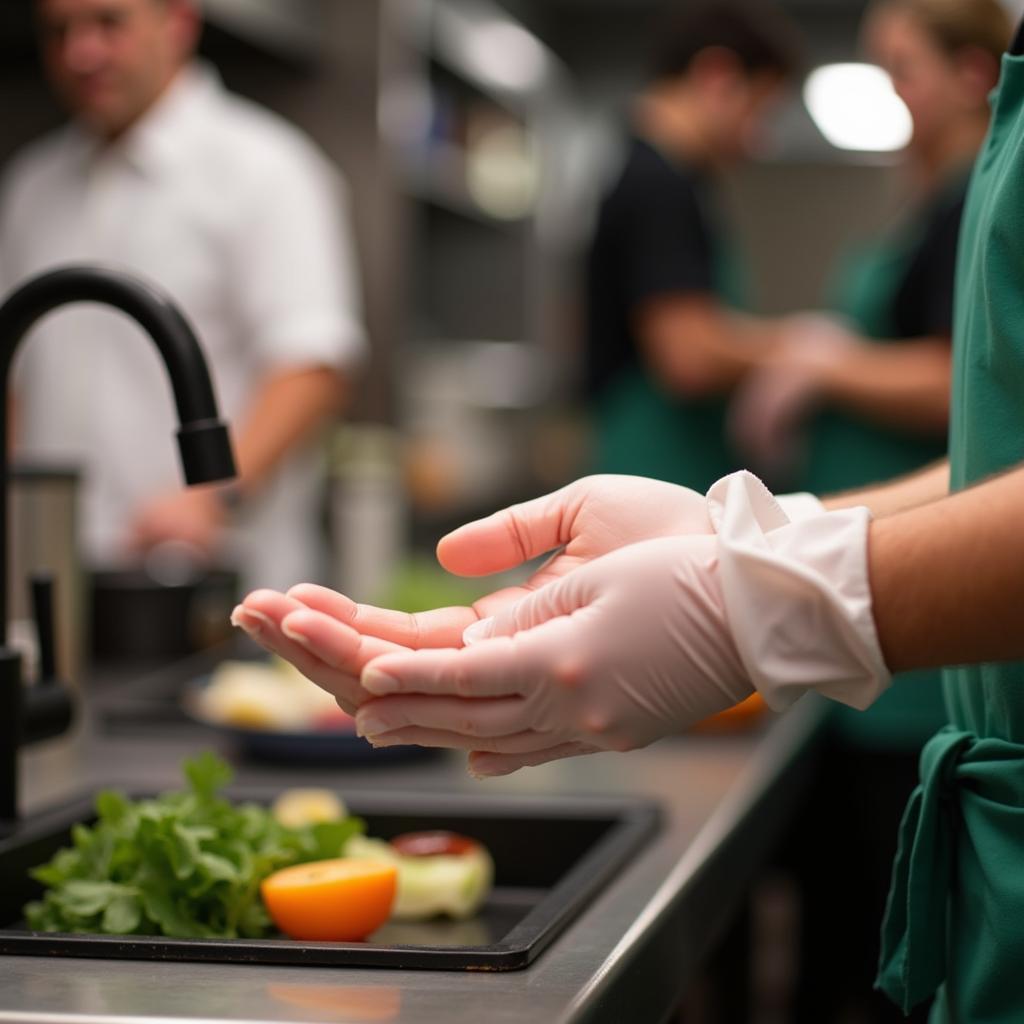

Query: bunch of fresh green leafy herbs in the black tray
25;754;364;938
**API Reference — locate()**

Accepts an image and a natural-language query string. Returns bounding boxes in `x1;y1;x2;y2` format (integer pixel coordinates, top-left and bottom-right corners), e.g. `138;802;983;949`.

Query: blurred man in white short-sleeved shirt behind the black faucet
0;0;367;586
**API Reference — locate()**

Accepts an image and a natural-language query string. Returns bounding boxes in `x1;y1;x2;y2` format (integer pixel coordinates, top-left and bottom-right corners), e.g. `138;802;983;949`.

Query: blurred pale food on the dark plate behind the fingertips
196;657;354;732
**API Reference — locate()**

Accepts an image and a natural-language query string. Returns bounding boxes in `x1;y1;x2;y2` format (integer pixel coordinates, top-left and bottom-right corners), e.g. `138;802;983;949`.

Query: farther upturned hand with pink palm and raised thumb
231;476;713;714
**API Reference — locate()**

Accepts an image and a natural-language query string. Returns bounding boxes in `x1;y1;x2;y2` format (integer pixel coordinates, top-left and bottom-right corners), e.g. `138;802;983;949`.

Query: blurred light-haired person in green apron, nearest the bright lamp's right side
733;0;1013;1022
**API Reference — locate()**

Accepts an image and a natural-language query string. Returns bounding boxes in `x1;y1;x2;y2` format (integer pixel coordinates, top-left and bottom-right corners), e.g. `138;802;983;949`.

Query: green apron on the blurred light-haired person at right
801;205;964;754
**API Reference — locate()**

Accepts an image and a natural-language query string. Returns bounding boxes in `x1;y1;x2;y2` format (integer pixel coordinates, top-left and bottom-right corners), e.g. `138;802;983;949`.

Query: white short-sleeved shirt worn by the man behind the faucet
0;65;366;588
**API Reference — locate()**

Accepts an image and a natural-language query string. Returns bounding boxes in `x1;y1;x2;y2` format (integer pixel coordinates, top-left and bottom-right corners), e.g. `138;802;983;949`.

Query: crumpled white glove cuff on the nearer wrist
708;472;891;711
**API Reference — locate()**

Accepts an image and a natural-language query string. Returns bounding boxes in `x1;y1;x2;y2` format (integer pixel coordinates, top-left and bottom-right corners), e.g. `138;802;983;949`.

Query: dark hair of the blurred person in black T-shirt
651;0;803;81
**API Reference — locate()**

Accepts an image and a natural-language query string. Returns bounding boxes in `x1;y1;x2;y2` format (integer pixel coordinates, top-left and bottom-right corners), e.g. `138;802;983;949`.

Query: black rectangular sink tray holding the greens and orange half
0;788;658;971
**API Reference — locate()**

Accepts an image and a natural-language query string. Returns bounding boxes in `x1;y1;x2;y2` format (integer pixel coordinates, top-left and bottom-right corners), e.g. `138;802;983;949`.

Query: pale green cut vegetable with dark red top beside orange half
345;831;495;921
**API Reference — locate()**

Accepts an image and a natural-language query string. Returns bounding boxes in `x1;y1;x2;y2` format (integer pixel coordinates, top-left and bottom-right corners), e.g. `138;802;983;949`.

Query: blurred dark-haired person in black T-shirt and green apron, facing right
587;0;797;489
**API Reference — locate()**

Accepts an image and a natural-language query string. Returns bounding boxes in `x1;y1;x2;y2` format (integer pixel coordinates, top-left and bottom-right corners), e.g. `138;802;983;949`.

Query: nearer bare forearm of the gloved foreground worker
868;469;1024;672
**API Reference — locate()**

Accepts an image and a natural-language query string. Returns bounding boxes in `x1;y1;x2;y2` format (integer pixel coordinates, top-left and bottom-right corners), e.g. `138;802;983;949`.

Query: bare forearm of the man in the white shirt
234;367;347;493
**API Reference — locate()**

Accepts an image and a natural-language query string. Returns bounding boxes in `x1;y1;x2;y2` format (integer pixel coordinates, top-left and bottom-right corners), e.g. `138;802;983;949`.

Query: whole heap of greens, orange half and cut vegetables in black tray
25;754;494;941
